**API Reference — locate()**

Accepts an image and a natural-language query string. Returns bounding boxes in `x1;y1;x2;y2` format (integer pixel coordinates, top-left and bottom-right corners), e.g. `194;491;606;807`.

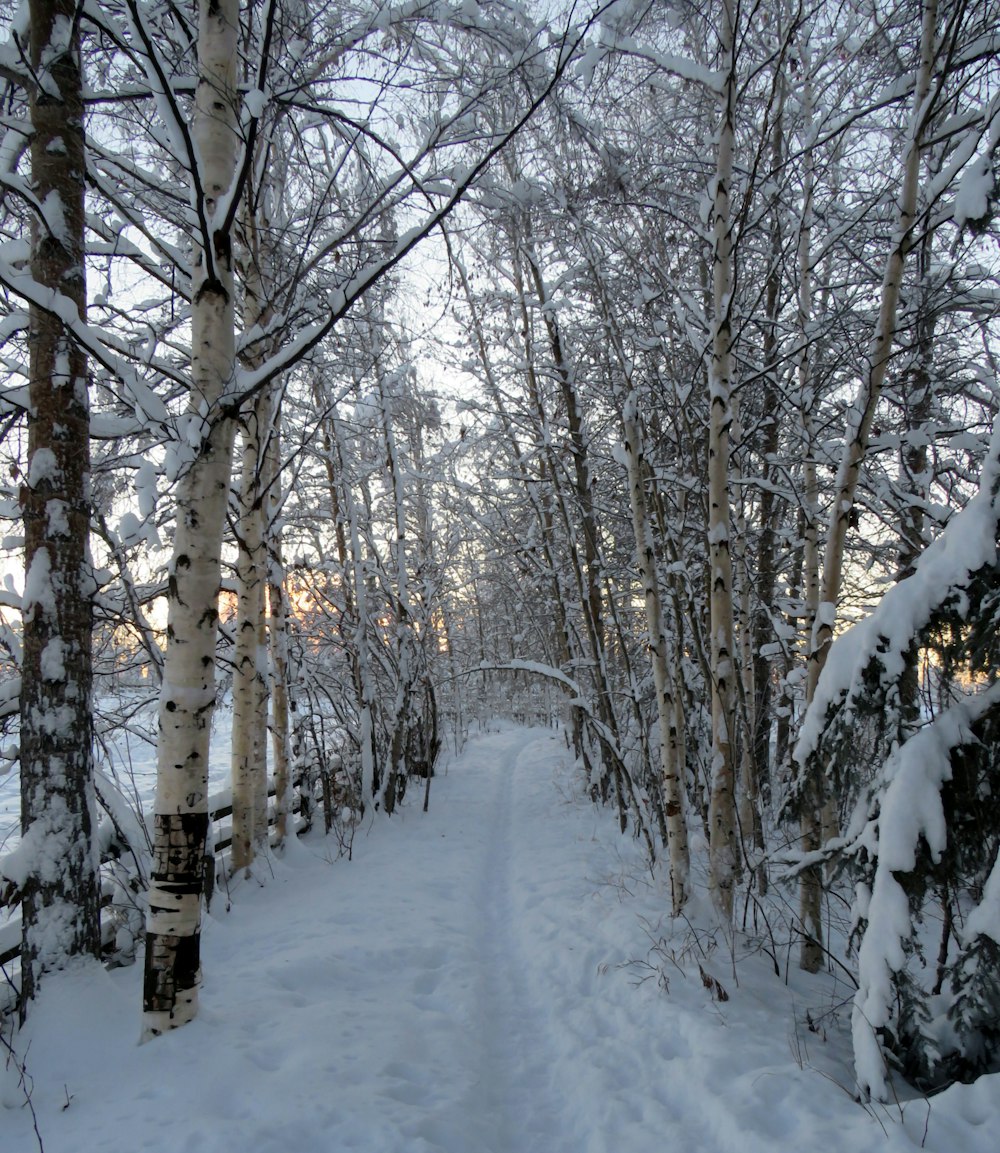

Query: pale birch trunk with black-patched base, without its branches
143;0;239;1039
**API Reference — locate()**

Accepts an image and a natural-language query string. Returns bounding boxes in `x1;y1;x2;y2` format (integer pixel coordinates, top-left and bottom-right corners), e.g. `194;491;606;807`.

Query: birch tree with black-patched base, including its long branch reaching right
134;0;604;1035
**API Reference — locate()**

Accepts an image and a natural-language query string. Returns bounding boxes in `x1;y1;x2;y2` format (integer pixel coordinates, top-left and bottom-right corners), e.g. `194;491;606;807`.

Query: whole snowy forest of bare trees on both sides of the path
0;0;1000;1120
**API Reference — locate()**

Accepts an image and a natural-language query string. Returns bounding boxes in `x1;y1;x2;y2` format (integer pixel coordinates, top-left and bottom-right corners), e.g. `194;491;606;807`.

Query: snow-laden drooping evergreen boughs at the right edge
795;420;1000;1100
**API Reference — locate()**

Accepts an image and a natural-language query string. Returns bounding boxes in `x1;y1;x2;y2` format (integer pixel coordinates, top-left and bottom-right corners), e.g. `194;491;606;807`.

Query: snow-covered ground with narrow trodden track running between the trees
0;728;1000;1153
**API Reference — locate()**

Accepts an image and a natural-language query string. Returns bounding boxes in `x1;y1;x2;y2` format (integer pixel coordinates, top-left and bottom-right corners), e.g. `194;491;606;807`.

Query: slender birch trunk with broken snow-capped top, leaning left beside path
622;392;690;917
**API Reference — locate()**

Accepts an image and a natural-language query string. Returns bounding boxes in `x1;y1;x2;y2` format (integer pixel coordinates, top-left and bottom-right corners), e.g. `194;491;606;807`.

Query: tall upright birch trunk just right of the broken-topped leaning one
708;0;739;921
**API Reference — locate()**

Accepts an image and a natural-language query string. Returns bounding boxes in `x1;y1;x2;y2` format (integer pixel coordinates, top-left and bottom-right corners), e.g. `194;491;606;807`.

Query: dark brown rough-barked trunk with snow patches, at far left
17;0;100;1012
